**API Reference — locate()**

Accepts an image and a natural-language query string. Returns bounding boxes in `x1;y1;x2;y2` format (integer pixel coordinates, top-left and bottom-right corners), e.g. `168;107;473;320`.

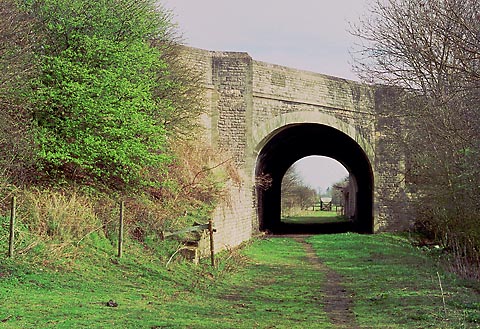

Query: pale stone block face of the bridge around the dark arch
179;47;406;251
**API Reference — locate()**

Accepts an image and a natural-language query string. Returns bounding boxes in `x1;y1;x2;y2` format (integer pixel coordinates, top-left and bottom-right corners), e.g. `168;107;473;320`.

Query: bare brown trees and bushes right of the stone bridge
353;0;480;279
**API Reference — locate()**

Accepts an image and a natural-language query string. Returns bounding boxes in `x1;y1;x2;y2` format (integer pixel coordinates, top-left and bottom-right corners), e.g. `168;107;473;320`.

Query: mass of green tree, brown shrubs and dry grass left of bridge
0;0;232;260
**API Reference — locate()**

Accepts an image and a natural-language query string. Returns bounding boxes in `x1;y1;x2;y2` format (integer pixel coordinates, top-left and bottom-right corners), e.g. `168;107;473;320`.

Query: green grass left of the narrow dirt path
0;234;327;328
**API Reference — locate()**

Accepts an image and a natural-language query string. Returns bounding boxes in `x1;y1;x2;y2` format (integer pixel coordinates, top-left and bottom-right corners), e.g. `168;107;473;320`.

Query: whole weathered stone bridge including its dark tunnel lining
180;48;407;250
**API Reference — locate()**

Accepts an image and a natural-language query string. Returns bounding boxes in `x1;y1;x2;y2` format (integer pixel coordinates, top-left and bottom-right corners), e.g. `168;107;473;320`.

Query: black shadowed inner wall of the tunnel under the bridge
256;123;373;233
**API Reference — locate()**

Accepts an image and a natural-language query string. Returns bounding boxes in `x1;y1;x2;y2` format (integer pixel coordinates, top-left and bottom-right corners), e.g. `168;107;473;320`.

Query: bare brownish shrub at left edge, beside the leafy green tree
0;0;39;185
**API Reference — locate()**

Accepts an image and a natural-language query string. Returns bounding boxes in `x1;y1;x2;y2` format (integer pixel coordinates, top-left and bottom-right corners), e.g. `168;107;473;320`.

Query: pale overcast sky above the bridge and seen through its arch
162;0;368;190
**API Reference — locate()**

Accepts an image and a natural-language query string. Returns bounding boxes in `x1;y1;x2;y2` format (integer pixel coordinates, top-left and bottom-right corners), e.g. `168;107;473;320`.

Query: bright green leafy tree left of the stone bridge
28;0;180;186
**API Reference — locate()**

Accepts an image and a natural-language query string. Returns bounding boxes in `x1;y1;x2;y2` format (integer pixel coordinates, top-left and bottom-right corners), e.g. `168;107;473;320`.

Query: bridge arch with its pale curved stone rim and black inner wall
253;112;374;233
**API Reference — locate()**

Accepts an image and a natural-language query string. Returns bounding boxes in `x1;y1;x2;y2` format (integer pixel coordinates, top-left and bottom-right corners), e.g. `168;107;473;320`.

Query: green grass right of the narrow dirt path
309;234;480;328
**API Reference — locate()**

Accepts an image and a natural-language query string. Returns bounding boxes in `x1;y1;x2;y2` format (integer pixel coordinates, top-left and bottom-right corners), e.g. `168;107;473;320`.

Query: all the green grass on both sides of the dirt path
0;234;480;328
